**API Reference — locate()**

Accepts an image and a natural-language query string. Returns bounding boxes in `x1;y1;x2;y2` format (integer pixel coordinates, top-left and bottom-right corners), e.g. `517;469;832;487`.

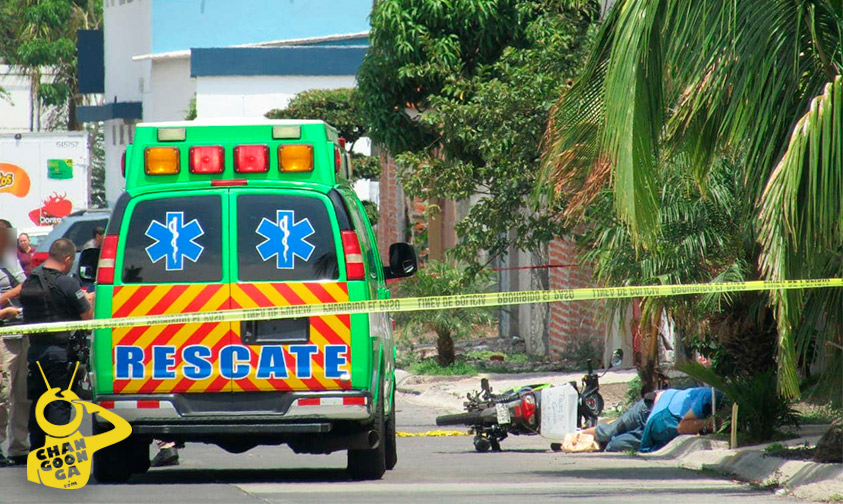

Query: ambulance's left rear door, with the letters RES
111;189;231;394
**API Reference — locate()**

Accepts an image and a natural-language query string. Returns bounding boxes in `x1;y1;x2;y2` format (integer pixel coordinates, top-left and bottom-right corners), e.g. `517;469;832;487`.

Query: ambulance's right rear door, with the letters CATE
229;189;351;392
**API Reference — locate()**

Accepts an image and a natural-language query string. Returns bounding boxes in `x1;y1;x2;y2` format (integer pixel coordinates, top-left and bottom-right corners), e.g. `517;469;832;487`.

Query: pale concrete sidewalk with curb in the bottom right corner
641;425;843;502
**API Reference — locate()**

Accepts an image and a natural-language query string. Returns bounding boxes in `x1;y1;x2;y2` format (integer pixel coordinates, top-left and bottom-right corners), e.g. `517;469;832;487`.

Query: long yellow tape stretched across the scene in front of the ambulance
0;278;843;336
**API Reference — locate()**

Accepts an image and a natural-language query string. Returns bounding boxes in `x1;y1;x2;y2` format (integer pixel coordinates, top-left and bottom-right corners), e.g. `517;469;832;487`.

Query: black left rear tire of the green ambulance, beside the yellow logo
91;419;150;483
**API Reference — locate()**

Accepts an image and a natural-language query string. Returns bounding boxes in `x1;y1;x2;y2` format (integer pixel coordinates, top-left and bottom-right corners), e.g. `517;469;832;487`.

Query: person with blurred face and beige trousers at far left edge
0;220;30;466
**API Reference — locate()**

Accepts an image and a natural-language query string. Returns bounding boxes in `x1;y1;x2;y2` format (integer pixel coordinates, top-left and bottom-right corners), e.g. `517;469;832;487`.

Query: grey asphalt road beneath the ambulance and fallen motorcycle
0;394;790;504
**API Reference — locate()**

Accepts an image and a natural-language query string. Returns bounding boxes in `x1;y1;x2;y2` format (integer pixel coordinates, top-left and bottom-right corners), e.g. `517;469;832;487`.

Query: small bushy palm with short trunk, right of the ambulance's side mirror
395;261;493;367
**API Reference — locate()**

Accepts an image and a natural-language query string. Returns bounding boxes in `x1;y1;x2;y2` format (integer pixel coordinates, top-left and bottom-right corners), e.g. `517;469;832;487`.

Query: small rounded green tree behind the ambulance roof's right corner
266;88;380;180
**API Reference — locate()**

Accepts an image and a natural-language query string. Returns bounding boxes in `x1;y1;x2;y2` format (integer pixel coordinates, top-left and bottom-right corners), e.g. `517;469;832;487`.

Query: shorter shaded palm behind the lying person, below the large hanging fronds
579;157;776;388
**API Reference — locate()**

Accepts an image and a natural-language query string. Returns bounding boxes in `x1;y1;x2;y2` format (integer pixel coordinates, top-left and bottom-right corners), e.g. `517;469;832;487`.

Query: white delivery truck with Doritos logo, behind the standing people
0;131;90;234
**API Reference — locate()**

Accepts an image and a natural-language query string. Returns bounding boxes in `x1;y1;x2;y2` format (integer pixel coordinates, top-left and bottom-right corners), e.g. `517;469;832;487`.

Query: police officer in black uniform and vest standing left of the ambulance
20;238;94;450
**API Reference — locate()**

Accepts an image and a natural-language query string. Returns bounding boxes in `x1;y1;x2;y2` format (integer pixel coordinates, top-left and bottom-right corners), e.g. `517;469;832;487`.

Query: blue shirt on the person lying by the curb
639;387;722;453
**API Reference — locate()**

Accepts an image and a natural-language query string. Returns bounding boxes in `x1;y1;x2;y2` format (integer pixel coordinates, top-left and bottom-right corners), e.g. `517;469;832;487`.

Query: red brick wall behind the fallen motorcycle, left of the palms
548;237;603;358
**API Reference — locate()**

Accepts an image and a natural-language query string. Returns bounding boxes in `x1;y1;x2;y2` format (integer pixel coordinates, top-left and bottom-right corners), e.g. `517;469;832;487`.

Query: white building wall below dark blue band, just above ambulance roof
196;75;356;119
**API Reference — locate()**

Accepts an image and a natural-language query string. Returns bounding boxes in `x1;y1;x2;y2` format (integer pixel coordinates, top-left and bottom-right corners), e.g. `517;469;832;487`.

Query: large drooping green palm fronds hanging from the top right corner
543;0;843;401
